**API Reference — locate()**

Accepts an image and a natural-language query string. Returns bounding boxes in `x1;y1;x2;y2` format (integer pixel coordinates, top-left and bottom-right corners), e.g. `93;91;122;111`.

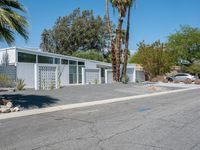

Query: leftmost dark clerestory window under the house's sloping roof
18;52;36;63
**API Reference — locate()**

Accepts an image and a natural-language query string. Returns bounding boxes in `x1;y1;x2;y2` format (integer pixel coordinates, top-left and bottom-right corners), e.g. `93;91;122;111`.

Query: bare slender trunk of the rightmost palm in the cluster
122;6;131;81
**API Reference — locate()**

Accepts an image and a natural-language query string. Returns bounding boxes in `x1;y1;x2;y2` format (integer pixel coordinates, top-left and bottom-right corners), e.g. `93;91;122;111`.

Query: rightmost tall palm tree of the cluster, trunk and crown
122;0;136;81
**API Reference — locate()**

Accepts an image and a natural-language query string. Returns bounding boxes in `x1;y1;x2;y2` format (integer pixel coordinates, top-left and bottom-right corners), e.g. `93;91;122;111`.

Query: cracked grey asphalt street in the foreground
0;89;200;150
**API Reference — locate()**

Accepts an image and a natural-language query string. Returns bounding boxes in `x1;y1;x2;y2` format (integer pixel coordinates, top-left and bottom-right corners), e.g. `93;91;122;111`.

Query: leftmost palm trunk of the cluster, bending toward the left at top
106;0;116;81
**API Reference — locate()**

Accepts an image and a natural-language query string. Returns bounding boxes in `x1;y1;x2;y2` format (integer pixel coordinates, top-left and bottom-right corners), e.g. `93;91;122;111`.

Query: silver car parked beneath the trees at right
166;73;196;81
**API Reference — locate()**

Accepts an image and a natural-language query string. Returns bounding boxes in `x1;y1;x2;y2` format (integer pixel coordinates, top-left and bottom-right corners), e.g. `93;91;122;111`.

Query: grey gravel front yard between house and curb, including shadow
0;83;178;109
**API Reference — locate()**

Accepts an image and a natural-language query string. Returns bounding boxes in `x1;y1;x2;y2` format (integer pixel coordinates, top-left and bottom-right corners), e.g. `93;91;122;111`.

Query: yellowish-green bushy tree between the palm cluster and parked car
135;41;173;78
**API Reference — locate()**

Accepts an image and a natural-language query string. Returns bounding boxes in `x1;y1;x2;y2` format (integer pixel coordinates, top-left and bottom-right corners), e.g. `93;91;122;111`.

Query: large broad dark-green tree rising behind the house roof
41;9;109;55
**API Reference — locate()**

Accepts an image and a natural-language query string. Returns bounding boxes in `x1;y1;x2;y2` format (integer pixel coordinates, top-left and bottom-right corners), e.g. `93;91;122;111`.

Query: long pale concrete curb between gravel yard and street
0;87;200;120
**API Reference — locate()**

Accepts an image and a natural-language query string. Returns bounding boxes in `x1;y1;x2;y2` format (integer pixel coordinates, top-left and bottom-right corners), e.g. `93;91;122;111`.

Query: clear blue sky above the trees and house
0;0;200;52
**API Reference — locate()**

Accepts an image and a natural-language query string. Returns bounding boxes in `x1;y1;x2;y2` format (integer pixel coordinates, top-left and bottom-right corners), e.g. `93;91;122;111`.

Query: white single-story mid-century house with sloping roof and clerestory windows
0;47;136;90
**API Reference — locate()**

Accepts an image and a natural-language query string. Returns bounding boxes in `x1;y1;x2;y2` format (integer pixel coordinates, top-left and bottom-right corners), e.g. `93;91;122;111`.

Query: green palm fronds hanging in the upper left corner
0;0;28;45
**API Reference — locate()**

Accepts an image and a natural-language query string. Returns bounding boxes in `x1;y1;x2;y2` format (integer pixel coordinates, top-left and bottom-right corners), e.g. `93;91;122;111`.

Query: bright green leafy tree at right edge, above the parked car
167;26;200;64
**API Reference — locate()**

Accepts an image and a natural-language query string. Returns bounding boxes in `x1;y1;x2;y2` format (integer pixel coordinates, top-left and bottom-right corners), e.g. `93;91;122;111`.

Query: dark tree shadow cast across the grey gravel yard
1;94;59;109
